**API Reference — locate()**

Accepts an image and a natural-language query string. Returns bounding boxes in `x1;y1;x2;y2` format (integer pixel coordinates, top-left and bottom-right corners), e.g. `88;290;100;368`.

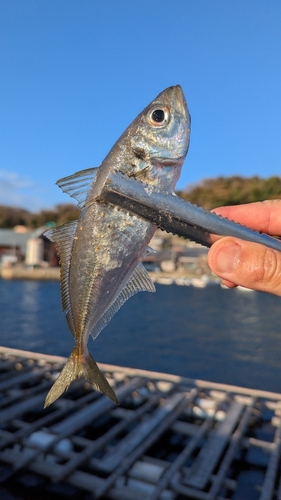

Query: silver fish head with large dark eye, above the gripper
94;85;190;197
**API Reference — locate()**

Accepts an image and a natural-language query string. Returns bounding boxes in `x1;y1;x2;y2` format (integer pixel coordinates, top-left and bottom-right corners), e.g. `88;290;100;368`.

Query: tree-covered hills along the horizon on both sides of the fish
0;176;281;229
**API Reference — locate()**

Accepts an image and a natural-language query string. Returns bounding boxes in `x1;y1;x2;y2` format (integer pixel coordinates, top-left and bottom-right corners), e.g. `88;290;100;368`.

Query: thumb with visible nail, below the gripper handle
208;237;281;295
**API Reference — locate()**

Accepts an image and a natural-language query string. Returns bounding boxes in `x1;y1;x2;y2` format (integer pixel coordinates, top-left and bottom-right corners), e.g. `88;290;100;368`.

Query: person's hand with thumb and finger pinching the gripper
208;200;281;295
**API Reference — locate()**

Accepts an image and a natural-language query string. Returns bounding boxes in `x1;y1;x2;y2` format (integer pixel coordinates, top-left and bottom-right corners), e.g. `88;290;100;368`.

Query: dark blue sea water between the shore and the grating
0;280;281;392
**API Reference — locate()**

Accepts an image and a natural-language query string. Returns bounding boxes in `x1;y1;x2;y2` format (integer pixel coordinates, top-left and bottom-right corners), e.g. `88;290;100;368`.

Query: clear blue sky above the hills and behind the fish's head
0;0;281;211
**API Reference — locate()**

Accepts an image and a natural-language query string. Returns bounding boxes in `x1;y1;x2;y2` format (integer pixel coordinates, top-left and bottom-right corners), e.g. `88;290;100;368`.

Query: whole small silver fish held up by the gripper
45;85;190;407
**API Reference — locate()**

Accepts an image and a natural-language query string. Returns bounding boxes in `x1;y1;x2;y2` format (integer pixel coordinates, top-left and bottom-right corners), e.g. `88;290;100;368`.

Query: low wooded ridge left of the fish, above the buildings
0;203;79;229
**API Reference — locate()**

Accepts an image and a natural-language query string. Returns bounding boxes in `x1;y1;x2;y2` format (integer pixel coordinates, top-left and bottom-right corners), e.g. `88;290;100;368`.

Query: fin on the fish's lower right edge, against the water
91;262;155;339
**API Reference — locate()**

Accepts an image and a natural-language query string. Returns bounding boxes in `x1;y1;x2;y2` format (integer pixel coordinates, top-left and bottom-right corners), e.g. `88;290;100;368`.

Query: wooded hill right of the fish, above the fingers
177;176;281;209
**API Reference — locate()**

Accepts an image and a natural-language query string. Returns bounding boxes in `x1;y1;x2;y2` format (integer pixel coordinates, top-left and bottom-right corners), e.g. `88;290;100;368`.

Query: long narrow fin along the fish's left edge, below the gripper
44;220;78;335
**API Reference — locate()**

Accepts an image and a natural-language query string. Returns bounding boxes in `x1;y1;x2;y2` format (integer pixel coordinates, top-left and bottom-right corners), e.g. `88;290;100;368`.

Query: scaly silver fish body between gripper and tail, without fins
69;203;156;345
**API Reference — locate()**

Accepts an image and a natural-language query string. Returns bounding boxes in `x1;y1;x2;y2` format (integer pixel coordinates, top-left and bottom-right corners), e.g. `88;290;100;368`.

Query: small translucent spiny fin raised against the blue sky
56;167;99;208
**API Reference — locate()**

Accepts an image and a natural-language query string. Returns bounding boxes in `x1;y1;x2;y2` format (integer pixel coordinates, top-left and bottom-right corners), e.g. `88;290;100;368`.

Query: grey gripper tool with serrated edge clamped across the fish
99;172;281;251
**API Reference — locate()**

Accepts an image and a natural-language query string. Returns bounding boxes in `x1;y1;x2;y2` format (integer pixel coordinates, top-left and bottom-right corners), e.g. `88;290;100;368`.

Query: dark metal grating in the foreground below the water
0;347;281;500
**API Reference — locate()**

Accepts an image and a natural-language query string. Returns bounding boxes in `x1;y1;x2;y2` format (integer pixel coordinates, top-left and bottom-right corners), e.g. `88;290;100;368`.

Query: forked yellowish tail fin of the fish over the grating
44;345;118;408
